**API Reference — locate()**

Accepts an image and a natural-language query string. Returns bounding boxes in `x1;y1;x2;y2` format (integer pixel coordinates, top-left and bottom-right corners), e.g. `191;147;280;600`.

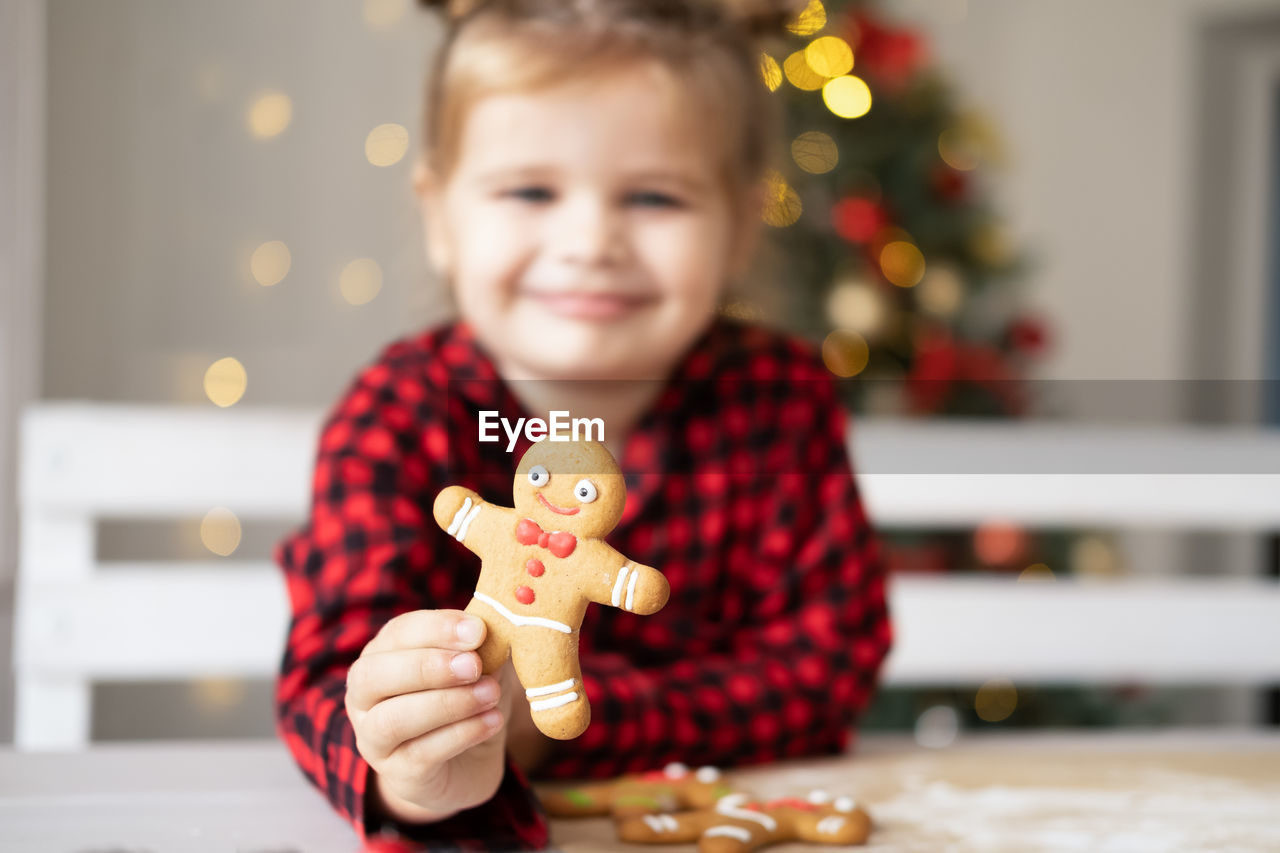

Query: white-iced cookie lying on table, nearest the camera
618;790;870;853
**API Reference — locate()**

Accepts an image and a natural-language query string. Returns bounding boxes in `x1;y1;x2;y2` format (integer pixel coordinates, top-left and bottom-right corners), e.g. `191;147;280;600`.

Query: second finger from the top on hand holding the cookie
347;648;480;711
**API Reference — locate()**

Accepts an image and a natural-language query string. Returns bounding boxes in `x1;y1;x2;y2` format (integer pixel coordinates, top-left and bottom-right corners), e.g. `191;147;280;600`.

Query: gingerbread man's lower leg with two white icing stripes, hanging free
511;625;591;740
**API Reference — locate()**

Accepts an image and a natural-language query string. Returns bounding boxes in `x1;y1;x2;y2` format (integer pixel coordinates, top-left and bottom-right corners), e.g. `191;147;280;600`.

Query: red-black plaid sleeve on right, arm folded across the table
545;376;891;777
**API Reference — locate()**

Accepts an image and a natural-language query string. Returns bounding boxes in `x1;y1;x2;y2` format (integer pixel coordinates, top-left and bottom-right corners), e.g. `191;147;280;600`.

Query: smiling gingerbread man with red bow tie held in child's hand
434;441;671;740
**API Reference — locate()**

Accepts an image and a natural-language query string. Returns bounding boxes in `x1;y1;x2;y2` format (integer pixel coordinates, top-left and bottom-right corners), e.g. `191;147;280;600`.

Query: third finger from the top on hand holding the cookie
358;678;502;762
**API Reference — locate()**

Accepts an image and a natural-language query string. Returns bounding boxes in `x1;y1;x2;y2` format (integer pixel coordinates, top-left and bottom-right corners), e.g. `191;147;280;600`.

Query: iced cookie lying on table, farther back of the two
541;762;733;820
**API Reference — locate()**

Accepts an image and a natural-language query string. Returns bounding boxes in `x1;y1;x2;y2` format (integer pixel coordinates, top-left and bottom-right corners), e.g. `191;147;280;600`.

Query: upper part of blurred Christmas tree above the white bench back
762;0;1047;416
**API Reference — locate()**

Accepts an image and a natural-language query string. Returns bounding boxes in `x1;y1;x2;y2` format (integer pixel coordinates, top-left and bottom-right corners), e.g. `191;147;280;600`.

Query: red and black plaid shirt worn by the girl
275;320;891;849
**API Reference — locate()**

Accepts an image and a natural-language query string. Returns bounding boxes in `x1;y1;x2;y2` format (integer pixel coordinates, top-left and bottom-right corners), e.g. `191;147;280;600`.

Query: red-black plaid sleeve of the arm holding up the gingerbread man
275;350;548;850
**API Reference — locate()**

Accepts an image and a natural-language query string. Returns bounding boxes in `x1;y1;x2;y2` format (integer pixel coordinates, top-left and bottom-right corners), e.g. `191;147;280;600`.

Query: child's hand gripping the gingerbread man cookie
346;610;515;822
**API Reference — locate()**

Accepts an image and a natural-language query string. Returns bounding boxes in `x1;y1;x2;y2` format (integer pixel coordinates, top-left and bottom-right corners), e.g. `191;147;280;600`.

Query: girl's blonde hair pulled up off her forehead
421;0;805;210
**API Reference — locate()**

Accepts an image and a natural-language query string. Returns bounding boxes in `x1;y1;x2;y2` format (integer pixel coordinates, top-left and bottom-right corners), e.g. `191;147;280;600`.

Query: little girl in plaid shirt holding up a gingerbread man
276;0;890;849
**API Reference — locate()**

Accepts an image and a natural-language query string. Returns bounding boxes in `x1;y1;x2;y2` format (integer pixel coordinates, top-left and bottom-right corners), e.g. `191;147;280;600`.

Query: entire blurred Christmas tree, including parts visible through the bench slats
730;0;1169;733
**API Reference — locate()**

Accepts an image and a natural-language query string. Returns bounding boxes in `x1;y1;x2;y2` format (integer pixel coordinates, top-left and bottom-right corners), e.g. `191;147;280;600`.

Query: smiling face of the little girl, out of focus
419;64;760;379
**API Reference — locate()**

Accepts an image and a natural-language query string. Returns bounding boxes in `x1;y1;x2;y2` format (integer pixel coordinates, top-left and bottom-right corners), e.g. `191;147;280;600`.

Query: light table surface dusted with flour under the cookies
0;731;1280;853
